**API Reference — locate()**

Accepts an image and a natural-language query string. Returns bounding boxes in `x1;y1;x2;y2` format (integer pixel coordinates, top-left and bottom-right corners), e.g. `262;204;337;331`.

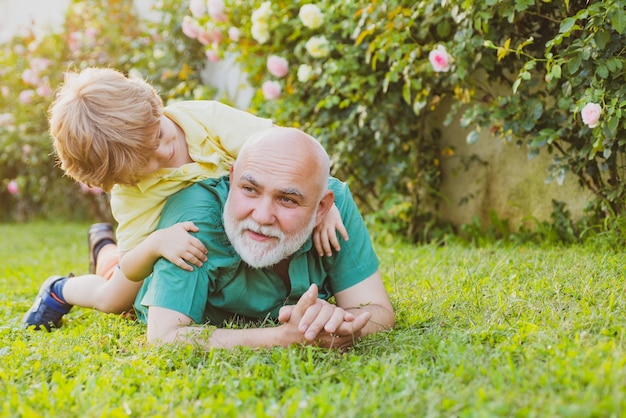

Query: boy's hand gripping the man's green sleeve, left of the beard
156;222;208;271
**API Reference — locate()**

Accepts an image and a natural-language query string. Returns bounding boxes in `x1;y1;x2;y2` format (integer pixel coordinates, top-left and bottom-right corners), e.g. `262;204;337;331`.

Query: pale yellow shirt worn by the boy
111;100;272;251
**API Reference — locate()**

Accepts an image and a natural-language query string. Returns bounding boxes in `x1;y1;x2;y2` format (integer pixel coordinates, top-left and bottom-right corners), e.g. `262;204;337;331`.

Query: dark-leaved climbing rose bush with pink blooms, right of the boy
186;0;626;239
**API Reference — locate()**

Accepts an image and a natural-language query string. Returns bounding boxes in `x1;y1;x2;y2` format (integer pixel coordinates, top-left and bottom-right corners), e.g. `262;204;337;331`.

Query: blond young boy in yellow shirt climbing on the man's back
23;68;347;331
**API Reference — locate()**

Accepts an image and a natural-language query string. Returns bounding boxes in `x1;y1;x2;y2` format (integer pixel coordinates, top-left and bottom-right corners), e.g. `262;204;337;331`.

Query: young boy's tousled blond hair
49;68;163;191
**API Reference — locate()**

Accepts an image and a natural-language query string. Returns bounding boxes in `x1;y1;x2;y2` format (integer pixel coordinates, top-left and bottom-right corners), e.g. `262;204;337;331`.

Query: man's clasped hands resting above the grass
278;284;371;349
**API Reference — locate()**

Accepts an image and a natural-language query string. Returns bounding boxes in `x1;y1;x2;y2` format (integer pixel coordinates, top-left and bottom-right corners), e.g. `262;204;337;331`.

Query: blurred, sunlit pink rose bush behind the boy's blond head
0;0;208;220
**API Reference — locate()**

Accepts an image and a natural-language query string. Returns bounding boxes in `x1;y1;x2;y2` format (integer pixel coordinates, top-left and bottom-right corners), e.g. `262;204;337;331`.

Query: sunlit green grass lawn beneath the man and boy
0;224;626;417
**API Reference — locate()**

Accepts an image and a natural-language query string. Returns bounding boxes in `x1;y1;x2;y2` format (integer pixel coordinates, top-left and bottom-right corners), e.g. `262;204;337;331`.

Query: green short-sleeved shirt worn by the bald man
135;176;378;325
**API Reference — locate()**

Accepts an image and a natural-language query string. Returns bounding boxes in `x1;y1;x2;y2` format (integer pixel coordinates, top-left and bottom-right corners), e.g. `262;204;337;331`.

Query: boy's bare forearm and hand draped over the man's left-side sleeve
120;222;207;282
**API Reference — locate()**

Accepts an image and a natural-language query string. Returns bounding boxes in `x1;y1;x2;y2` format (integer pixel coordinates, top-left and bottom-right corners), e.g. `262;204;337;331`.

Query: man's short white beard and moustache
224;196;315;269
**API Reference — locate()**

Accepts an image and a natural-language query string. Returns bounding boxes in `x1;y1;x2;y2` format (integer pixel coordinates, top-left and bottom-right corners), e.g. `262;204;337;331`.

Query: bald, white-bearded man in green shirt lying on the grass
135;127;395;349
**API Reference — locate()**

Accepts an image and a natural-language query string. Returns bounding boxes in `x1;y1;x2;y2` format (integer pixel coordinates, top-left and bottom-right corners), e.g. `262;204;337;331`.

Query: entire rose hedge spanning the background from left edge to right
0;0;626;240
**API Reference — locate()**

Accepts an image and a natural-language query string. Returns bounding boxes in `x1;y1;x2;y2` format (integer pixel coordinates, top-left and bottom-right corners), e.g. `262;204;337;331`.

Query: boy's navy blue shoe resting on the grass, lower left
22;274;74;331
